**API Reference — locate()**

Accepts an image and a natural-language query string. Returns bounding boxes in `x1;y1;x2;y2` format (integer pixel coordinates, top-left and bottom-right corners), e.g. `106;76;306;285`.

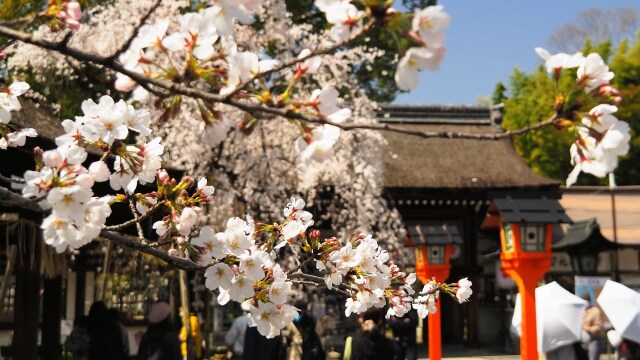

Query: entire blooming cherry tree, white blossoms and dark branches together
0;0;629;344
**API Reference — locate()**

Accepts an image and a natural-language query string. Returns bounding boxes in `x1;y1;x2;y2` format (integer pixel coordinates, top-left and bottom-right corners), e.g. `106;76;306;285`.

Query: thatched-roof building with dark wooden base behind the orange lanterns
378;105;561;345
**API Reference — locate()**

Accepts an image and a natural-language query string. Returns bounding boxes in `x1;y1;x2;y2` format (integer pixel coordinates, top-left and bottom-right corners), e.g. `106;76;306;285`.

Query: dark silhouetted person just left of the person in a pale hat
89;301;128;360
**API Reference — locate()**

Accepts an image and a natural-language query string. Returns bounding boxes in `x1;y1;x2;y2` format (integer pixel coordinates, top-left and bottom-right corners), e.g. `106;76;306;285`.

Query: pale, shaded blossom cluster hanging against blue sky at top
395;5;451;91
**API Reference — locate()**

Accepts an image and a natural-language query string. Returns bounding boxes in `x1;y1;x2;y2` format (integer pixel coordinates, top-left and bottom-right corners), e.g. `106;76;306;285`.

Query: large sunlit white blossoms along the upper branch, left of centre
115;2;353;170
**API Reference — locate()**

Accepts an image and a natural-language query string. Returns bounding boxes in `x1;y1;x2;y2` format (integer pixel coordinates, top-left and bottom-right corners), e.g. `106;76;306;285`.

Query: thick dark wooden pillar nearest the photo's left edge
11;232;42;360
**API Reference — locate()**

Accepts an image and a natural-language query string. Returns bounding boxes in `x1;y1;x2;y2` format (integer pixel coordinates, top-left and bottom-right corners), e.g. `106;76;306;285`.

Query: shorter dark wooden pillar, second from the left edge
42;276;62;360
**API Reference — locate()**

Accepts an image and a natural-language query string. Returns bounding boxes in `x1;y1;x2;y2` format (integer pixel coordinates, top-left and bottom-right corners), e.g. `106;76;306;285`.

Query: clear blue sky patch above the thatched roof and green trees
395;0;640;105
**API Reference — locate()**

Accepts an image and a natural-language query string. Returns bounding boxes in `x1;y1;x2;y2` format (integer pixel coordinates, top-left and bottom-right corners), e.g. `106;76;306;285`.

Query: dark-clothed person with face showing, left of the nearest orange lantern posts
351;309;396;360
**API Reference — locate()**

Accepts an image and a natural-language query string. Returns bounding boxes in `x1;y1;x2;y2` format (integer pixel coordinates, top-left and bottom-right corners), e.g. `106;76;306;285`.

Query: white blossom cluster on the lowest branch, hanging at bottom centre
190;198;471;338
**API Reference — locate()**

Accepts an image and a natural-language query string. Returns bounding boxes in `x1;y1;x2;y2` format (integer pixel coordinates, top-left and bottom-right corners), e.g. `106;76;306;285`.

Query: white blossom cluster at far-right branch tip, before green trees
535;48;631;186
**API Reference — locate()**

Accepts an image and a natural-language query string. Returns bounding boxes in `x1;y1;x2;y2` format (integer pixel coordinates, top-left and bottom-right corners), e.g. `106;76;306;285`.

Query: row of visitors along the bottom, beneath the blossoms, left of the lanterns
65;294;418;360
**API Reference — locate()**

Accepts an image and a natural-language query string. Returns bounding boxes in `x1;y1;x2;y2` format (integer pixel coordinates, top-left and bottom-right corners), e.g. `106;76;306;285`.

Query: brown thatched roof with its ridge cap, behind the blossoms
378;105;559;189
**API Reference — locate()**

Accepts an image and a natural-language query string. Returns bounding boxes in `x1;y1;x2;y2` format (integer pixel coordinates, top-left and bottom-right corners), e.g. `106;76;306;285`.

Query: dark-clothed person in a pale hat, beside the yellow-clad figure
136;301;182;360
